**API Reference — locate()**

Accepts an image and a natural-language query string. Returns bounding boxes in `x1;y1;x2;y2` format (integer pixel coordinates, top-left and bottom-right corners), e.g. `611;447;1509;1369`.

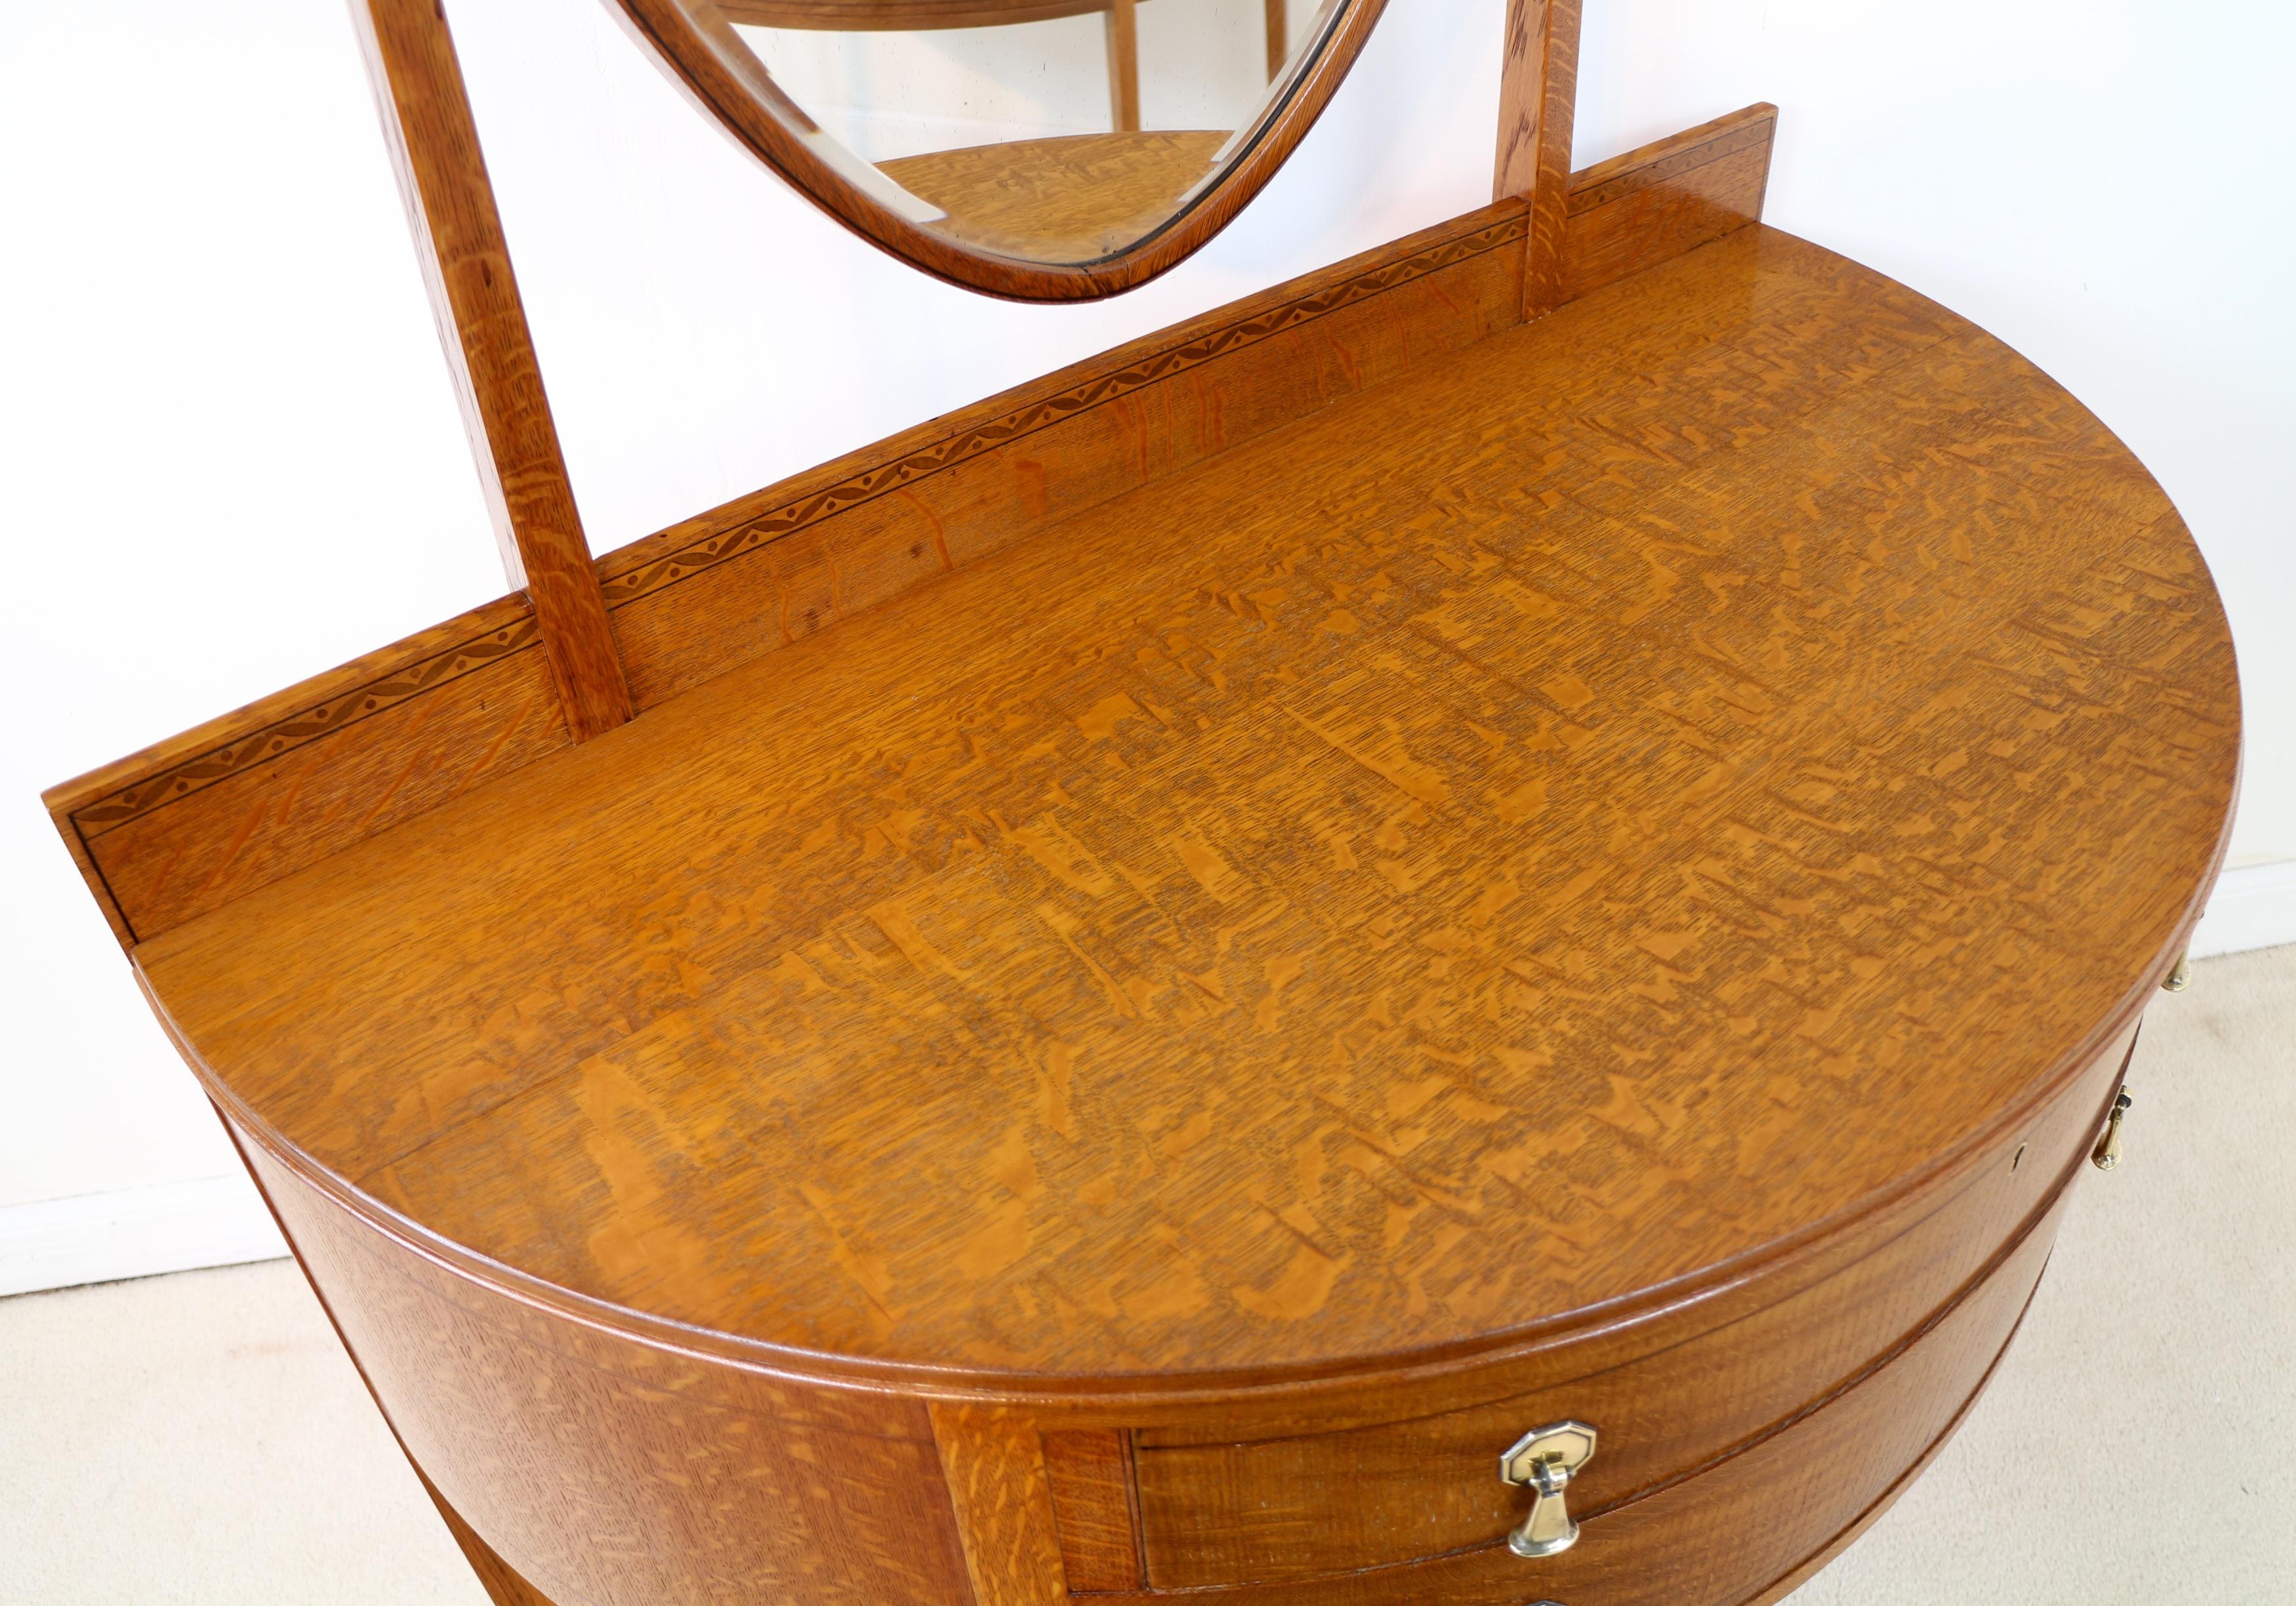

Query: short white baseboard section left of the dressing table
0;1174;287;1296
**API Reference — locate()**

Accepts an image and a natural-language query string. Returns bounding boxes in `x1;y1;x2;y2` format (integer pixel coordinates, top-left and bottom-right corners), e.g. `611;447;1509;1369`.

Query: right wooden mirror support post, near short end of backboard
1490;0;1580;321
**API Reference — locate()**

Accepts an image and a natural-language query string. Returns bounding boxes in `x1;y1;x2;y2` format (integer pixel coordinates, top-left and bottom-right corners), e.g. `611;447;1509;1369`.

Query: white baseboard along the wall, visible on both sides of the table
0;859;2296;1296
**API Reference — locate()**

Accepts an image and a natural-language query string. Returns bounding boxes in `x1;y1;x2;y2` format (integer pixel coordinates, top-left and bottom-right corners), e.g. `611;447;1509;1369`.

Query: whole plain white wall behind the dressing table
0;0;2296;1289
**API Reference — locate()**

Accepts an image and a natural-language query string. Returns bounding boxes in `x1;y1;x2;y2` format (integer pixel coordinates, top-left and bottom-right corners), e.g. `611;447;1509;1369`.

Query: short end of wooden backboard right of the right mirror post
1561;104;1777;297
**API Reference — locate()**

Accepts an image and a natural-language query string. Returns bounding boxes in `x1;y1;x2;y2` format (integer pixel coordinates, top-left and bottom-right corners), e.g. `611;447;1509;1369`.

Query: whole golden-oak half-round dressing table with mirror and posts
46;0;2239;1606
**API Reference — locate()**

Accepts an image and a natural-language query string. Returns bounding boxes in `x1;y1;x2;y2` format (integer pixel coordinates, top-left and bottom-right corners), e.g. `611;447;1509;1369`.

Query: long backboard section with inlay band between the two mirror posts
604;207;1523;708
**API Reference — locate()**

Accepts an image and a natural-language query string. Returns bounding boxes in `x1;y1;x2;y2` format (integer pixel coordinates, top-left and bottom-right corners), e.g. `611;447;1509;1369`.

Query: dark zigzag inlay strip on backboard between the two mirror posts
604;211;1527;607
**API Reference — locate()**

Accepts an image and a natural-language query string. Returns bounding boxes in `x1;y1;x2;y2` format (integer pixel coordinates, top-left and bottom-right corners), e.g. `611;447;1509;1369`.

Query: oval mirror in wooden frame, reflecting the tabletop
618;0;1385;301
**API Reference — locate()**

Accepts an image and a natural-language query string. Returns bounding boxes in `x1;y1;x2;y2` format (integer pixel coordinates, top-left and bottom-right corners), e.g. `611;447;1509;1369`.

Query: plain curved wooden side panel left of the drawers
237;1133;969;1606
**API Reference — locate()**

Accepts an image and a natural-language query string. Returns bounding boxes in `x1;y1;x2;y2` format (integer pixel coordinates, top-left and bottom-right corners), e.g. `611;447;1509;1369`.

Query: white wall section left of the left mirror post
0;0;501;1241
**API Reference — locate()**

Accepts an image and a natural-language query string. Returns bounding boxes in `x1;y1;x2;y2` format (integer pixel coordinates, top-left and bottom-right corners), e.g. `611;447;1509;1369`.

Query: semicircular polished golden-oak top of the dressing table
138;228;2239;1381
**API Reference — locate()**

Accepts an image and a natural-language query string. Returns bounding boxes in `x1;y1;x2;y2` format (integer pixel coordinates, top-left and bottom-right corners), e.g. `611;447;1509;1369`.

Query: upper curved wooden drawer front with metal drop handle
1134;1024;2124;1590
